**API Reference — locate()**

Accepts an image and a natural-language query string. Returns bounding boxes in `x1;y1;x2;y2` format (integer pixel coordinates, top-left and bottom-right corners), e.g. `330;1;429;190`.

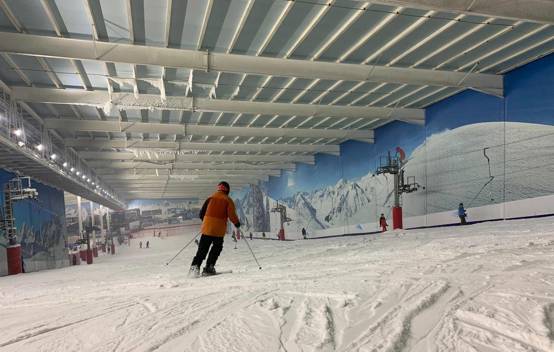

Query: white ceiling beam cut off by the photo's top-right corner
359;0;554;24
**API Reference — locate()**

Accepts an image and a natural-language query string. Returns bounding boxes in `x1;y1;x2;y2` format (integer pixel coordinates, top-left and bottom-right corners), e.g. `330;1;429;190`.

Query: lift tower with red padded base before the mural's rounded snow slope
376;147;420;230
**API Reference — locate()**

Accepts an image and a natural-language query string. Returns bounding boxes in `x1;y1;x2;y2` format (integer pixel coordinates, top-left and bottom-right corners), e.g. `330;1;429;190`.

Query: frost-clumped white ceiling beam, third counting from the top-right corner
12;86;422;123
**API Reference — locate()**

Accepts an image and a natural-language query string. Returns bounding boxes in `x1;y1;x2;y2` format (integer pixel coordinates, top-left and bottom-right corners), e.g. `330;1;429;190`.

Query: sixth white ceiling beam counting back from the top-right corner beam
79;151;315;165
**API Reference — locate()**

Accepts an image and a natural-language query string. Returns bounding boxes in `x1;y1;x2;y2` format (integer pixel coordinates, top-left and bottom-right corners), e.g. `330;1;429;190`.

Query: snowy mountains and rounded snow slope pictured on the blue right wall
236;122;554;238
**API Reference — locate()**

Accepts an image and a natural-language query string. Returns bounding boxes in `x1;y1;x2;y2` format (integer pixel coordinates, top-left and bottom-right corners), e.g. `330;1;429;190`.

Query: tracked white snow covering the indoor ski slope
0;218;554;352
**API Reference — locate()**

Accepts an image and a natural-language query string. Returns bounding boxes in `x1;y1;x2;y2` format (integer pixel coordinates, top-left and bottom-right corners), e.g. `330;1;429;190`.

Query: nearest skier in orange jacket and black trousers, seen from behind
189;181;240;276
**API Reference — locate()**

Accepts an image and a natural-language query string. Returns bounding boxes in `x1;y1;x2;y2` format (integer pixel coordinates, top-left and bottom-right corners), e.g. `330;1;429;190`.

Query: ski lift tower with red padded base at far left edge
1;177;38;275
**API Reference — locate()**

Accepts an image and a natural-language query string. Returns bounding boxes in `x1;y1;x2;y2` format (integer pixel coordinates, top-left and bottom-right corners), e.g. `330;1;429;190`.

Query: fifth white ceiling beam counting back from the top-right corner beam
64;138;340;155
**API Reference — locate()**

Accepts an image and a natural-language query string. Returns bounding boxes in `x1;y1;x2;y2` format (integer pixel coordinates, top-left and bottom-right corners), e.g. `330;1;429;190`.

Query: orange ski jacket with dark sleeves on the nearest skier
200;191;240;237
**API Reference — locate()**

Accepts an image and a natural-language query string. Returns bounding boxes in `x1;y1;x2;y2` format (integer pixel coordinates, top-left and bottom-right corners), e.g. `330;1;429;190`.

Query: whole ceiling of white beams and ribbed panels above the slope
0;0;554;204
